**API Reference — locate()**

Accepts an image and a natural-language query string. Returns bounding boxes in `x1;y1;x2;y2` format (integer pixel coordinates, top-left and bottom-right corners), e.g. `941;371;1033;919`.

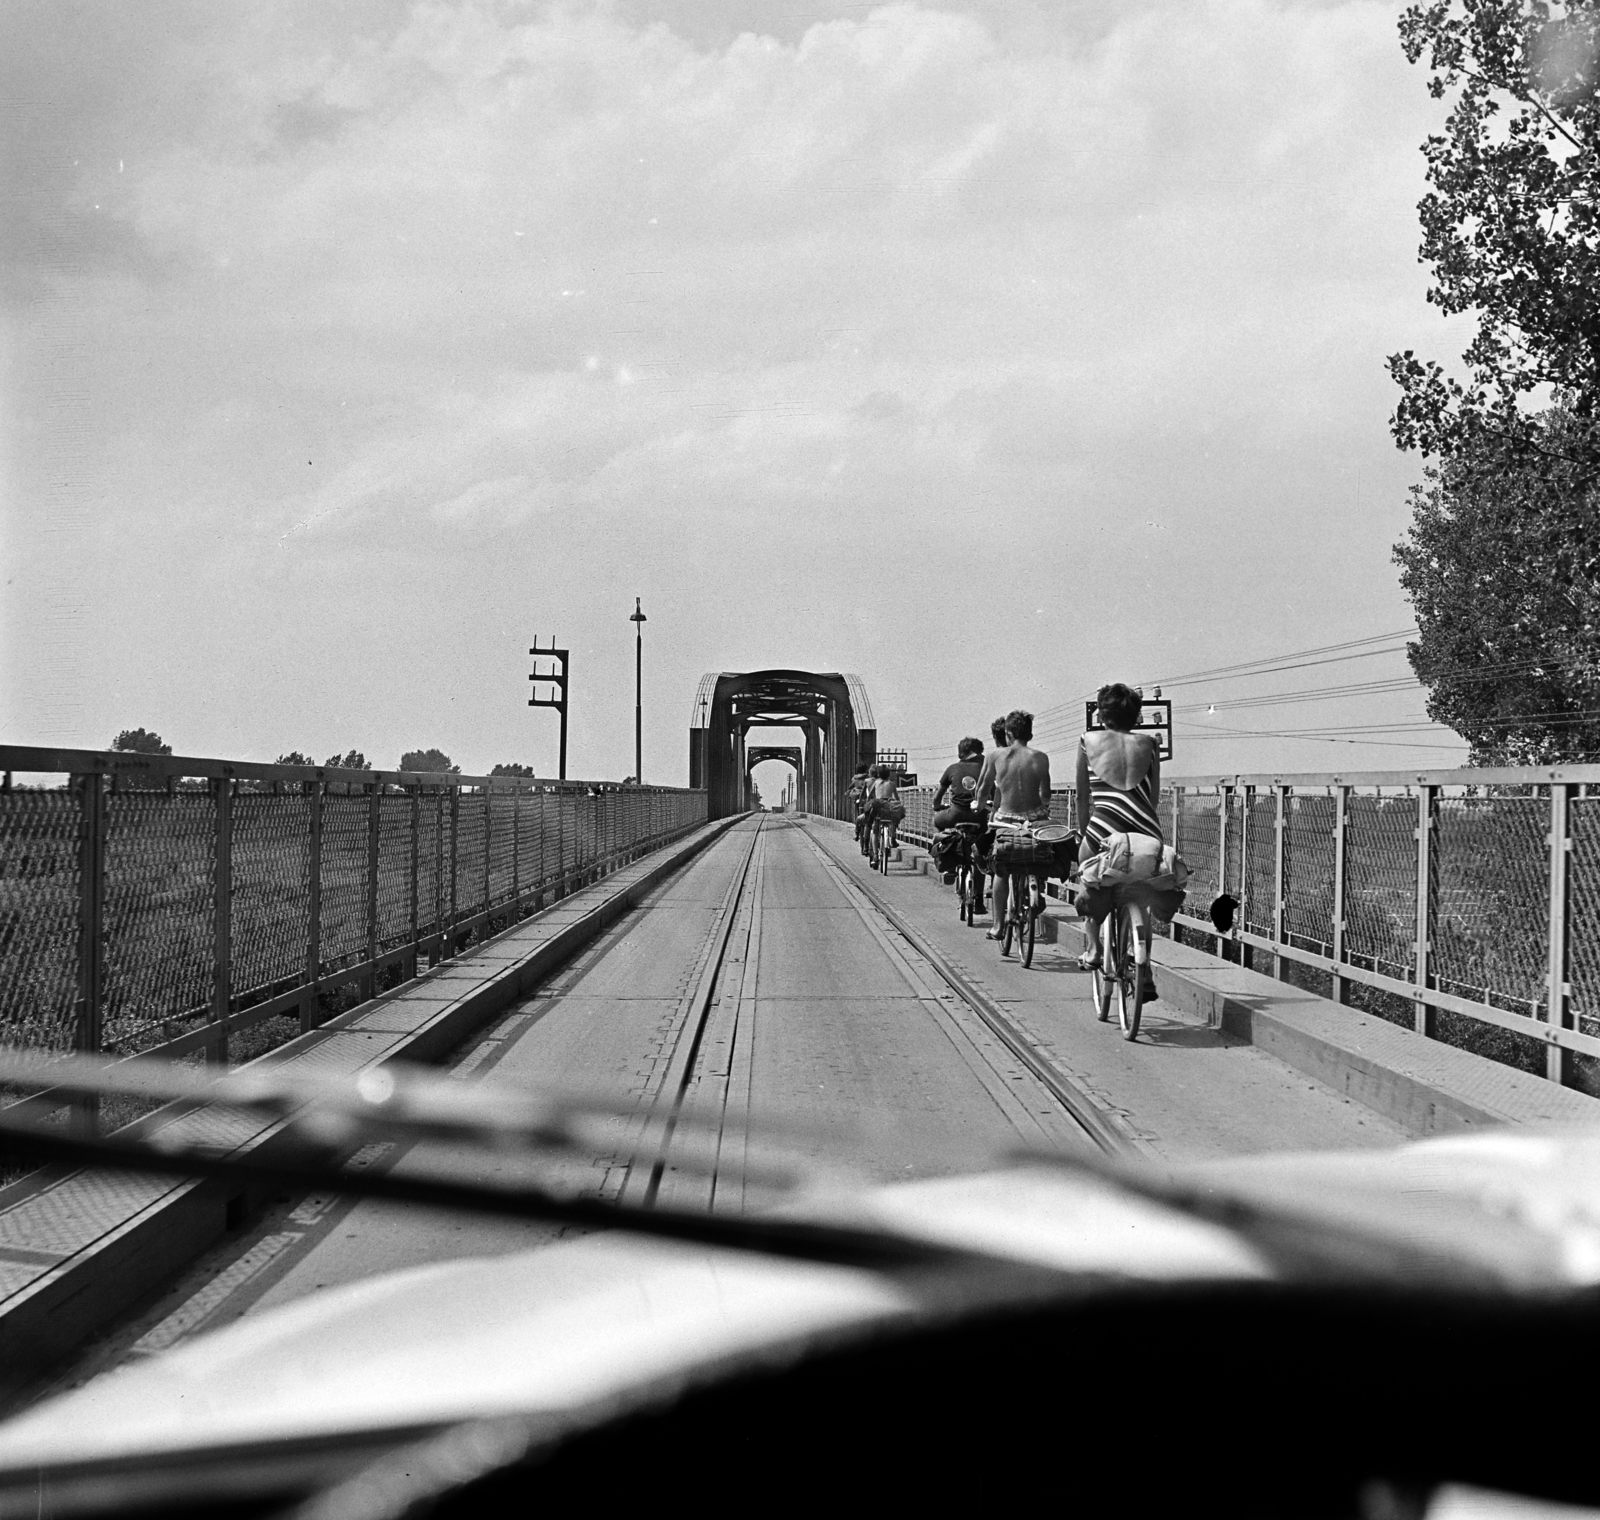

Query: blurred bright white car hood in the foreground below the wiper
0;1131;1600;1472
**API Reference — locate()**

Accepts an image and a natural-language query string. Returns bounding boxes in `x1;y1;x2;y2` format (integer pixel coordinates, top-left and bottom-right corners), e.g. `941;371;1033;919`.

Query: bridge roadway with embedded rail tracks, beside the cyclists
25;819;1405;1401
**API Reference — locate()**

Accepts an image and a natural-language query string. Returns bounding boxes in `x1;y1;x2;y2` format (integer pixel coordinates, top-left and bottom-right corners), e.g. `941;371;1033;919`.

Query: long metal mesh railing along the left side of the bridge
0;746;706;1061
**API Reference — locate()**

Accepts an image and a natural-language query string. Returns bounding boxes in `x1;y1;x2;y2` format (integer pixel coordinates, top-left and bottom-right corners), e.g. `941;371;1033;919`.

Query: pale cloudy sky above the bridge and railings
0;0;1467;784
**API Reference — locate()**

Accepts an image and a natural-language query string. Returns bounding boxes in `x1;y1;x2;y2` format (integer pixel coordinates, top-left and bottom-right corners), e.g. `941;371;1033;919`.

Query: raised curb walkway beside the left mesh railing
0;818;739;1397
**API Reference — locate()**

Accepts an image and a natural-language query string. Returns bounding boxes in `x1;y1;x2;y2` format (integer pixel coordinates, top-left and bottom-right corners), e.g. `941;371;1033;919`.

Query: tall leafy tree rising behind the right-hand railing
1389;0;1600;763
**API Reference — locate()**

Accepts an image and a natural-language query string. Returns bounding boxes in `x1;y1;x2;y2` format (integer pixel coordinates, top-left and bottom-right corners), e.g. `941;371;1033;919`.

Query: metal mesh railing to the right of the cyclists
899;765;1600;1082
